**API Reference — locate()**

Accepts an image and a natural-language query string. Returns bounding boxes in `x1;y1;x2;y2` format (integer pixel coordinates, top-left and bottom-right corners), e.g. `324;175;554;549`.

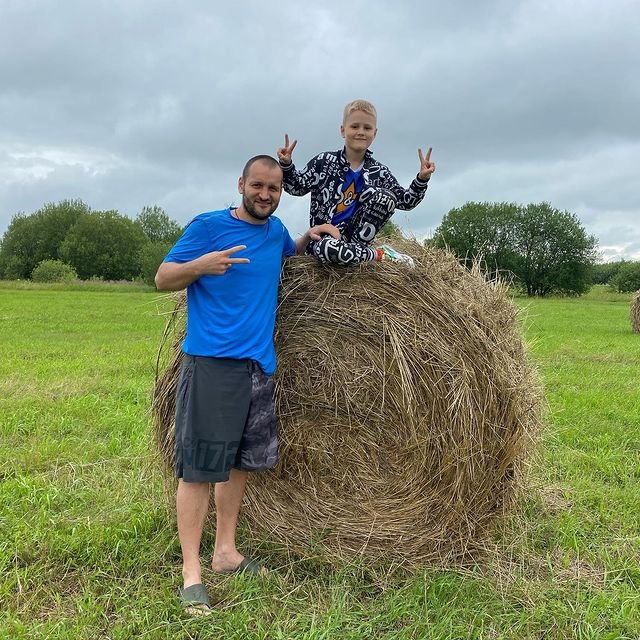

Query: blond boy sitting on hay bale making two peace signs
278;100;436;266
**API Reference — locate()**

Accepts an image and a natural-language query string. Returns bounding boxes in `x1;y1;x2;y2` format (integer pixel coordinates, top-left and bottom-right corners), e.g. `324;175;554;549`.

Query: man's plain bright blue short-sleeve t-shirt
164;209;296;375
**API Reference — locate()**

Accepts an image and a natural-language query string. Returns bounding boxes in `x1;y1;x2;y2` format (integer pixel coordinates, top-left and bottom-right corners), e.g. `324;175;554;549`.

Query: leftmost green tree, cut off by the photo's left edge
0;200;90;278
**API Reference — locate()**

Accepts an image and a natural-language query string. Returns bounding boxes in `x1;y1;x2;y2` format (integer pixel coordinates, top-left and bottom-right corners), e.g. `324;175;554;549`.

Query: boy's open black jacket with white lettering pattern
280;149;429;226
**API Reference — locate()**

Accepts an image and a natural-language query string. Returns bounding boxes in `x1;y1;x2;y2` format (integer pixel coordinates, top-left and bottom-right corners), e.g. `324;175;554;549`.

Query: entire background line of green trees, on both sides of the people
0;200;640;296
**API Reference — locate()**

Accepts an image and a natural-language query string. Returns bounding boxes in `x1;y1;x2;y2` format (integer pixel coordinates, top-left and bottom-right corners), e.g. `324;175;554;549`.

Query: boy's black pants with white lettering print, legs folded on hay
308;187;396;265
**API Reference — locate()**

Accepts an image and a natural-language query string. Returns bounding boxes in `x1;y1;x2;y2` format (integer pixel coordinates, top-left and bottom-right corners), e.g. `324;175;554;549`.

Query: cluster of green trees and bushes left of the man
0;200;182;282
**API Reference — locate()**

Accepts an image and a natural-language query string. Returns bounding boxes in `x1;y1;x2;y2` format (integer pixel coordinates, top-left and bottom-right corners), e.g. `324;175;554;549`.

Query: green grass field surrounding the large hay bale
0;283;640;640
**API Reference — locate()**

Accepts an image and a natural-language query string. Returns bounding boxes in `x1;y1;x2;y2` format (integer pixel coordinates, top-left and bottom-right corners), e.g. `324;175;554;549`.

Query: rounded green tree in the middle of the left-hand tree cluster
60;211;148;280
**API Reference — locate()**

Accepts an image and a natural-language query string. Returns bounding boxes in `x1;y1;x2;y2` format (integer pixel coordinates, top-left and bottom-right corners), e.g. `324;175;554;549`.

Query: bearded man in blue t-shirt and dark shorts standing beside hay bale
156;155;339;615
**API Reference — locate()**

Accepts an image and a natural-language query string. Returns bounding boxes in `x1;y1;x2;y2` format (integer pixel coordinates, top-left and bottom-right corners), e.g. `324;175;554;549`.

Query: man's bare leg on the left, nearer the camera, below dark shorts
176;479;209;588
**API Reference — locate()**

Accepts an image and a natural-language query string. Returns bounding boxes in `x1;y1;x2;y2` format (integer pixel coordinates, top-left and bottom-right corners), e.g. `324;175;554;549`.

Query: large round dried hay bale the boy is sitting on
154;243;541;564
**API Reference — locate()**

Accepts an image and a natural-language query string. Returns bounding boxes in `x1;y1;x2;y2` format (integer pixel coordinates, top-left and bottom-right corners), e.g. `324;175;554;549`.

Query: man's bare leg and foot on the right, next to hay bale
211;469;249;572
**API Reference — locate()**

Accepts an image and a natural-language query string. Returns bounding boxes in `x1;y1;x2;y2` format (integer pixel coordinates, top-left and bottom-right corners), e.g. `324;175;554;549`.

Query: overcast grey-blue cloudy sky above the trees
0;0;640;259
